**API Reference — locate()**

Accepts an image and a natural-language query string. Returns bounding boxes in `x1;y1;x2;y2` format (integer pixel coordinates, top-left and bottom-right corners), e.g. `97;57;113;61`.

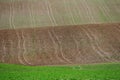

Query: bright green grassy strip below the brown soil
0;63;120;80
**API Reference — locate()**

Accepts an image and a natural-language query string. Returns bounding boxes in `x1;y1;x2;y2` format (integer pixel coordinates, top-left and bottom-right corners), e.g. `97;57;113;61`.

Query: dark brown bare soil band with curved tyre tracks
0;23;120;65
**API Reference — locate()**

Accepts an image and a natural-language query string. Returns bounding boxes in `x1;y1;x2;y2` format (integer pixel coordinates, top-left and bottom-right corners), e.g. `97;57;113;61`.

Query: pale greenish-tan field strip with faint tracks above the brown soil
0;0;120;29
